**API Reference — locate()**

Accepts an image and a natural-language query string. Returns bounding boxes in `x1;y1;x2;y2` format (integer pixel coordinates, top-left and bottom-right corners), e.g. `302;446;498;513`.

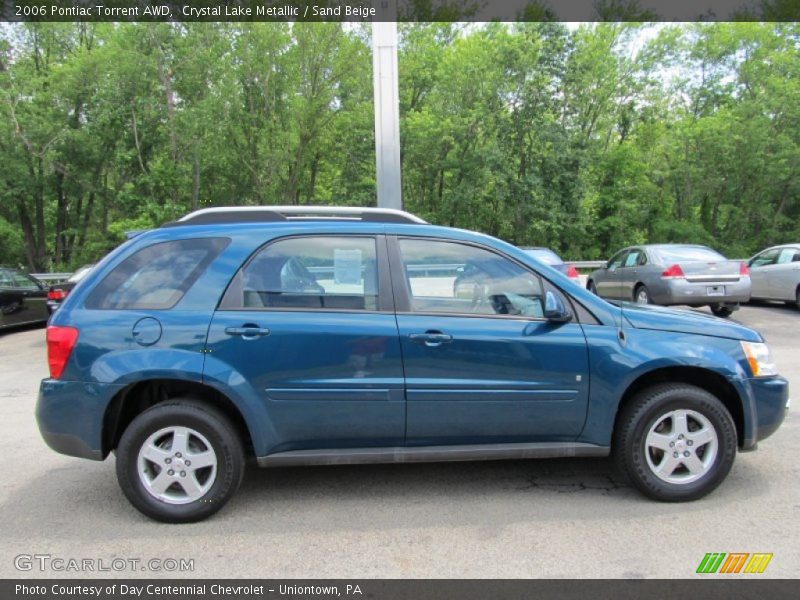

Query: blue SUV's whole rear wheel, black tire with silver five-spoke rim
116;399;245;523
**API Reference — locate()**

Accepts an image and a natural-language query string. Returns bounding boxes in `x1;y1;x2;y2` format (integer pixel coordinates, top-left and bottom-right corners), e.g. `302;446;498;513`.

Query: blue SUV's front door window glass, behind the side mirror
400;239;544;318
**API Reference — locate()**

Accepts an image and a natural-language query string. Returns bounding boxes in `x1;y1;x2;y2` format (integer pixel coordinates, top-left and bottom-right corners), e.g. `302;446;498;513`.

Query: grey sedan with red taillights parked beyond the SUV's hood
586;244;750;317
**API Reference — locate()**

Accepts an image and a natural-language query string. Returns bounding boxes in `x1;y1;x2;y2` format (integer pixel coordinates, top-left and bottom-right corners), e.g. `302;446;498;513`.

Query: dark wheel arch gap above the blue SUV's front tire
612;366;746;448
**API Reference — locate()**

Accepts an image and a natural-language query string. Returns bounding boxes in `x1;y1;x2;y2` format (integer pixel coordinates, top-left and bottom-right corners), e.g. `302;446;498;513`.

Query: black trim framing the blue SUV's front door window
386;235;600;325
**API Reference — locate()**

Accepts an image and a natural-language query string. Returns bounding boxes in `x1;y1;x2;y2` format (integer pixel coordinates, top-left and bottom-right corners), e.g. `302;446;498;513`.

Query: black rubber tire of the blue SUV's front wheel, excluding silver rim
613;383;737;502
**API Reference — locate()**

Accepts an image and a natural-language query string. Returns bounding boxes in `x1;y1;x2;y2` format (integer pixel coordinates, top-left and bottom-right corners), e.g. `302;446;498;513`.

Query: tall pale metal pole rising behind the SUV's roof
372;0;403;209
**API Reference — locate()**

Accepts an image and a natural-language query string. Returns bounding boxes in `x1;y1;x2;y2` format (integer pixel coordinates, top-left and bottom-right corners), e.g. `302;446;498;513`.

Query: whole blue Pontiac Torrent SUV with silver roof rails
36;207;788;522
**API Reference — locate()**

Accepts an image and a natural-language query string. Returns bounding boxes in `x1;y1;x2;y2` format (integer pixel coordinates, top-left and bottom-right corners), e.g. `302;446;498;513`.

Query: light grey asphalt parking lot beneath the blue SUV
0;304;800;578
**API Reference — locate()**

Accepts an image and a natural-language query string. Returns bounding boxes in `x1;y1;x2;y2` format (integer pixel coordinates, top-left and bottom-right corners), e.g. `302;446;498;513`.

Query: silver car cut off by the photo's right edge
748;244;800;308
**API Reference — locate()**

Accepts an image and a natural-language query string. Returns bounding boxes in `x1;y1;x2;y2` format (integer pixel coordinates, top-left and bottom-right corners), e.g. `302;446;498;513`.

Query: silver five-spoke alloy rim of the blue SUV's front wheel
644;409;719;484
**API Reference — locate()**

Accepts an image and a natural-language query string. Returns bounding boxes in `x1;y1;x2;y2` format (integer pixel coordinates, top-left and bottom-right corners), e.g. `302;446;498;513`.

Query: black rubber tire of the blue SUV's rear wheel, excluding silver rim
116;399;245;523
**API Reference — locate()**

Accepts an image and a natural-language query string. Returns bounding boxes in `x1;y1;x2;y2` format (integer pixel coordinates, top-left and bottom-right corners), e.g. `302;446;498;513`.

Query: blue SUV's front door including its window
390;238;589;445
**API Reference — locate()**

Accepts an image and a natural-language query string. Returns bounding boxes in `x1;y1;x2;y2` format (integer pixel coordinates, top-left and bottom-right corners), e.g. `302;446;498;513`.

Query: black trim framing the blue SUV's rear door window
215;233;395;315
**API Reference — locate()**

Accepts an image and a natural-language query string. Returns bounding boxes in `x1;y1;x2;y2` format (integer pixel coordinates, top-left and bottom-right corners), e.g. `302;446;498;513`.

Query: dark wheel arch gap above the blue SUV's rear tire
102;379;254;457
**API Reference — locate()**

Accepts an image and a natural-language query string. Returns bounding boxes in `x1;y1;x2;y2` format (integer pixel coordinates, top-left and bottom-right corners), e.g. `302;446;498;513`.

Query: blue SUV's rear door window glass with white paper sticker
222;236;378;310
